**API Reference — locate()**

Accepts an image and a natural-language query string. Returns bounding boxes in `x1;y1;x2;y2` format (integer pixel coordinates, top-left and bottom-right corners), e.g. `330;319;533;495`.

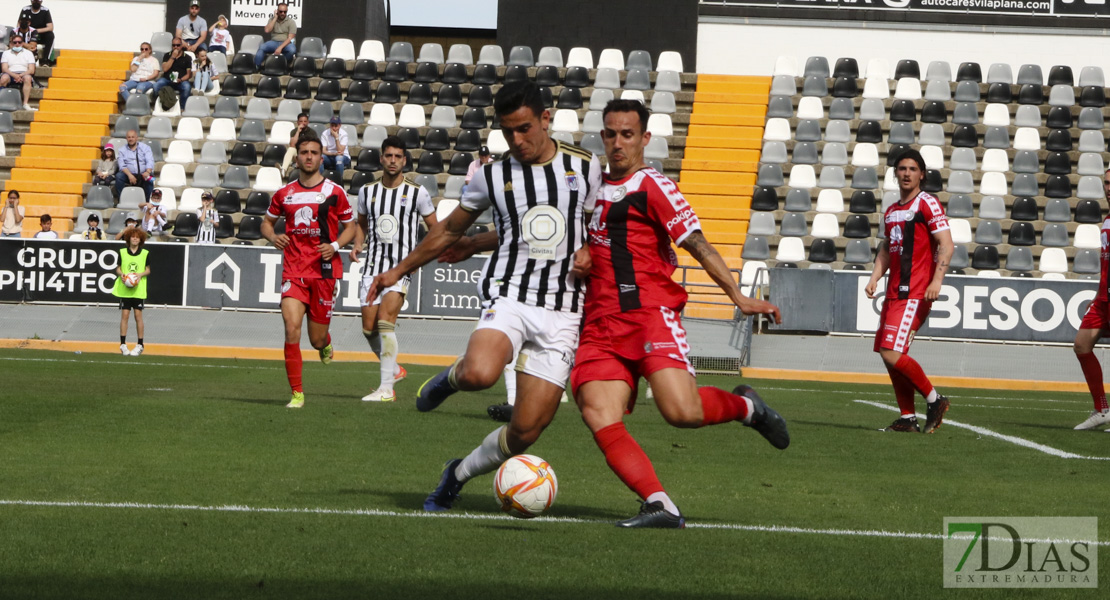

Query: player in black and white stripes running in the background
351;135;435;403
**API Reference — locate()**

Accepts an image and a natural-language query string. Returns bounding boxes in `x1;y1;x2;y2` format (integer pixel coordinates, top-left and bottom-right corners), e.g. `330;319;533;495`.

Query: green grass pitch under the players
0;350;1110;600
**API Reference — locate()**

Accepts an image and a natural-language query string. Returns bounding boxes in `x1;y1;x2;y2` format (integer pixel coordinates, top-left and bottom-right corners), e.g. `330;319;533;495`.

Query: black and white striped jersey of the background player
355;179;435;276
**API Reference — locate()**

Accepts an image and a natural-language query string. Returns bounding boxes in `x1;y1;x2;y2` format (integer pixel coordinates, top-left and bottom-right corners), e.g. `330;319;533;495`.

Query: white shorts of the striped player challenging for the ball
475;298;582;388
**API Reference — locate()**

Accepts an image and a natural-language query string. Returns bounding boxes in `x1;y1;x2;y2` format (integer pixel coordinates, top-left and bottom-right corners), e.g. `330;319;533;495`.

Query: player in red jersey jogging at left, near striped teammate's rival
262;133;357;408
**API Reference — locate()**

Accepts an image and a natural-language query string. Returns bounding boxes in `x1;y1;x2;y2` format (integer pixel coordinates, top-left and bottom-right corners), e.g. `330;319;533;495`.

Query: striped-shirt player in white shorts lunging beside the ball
370;82;602;510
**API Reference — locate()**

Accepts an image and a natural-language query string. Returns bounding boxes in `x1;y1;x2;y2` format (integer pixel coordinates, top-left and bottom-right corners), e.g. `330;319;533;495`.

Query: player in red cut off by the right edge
1073;171;1110;431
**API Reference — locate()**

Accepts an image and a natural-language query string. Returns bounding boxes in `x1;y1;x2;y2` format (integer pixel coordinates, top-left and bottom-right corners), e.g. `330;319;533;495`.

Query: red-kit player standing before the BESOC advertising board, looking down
865;150;952;434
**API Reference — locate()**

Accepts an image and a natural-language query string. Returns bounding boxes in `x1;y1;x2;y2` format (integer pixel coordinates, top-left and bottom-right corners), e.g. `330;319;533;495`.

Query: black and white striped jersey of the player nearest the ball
461;141;602;313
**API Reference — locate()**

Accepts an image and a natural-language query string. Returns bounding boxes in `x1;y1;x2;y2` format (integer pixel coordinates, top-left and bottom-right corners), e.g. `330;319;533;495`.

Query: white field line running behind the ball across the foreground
0;500;1110;546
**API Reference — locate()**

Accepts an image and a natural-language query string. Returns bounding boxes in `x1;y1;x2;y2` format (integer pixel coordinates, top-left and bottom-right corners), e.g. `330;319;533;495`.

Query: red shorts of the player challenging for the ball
571;306;694;393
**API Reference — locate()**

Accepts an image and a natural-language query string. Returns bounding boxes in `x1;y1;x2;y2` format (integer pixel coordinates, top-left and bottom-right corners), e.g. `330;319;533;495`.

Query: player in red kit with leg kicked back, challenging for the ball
571;100;790;528
